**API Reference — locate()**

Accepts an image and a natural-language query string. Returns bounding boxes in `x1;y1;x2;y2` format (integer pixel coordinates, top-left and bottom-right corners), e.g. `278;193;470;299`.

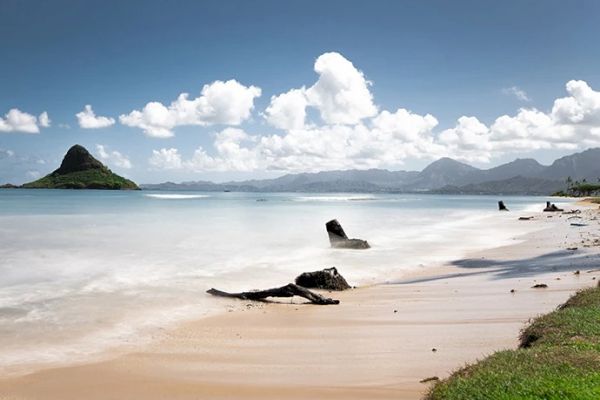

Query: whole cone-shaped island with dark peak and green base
22;145;139;190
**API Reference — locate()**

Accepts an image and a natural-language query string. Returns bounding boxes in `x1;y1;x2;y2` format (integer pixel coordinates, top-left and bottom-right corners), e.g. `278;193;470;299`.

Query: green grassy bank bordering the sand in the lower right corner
426;287;600;400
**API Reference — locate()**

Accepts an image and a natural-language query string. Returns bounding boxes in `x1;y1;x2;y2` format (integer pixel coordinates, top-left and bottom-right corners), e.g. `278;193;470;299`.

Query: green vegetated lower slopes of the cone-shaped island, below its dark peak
23;168;139;189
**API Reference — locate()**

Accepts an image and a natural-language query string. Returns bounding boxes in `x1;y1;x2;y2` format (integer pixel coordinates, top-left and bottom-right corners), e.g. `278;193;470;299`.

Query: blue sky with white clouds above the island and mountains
0;0;600;183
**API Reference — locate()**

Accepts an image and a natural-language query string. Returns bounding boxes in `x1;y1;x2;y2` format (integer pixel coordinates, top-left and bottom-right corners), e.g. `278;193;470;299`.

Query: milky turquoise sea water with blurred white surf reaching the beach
0;190;568;367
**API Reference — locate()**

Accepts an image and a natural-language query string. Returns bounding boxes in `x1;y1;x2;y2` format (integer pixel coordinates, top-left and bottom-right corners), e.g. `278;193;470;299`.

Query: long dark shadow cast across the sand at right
392;250;600;284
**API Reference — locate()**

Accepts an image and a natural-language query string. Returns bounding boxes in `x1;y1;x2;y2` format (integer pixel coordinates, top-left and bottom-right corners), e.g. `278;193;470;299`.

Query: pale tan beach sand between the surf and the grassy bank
0;205;600;400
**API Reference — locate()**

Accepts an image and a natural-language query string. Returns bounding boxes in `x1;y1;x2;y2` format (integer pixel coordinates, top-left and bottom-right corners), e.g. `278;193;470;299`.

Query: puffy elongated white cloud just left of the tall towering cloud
119;80;261;138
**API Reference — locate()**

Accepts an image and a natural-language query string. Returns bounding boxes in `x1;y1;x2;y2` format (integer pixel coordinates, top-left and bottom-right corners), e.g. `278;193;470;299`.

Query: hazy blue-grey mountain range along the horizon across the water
141;148;600;194
